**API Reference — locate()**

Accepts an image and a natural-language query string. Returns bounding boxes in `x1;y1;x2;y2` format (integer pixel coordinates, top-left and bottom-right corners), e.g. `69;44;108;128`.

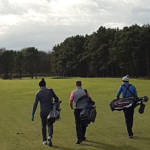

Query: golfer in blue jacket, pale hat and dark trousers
117;75;137;138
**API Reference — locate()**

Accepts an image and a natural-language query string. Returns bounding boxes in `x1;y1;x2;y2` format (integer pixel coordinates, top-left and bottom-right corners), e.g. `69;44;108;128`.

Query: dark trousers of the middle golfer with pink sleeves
74;109;87;140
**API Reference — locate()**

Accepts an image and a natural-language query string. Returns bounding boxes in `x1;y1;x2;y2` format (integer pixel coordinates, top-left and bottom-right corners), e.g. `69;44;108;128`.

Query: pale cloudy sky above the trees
0;0;150;51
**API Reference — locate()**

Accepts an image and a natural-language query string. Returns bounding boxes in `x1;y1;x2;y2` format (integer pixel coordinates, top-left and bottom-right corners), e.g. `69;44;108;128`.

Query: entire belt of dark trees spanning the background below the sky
0;25;150;78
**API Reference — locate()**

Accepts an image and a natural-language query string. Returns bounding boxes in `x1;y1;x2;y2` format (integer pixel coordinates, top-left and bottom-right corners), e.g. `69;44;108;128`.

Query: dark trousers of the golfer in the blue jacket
123;107;134;136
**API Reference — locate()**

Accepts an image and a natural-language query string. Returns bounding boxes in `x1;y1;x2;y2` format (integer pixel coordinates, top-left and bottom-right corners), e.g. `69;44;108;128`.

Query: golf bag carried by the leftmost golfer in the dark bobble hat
47;101;61;123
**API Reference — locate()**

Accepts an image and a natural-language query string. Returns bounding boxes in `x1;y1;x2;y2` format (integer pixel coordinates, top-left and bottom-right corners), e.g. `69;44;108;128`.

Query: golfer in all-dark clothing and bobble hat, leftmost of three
32;79;59;146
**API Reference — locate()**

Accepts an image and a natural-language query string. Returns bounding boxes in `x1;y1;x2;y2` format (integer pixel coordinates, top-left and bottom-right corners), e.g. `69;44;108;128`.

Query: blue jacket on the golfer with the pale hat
117;82;137;98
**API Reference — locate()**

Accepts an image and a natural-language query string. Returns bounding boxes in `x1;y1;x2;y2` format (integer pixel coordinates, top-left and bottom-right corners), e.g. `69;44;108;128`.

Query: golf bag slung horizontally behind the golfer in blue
109;96;148;113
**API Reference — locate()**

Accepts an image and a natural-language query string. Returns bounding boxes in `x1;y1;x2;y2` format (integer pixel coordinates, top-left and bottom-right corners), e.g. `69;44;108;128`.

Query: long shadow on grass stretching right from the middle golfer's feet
82;140;138;150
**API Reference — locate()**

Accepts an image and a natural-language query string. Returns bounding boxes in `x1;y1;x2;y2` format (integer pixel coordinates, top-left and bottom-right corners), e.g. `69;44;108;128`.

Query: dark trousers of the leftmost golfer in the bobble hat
40;113;53;141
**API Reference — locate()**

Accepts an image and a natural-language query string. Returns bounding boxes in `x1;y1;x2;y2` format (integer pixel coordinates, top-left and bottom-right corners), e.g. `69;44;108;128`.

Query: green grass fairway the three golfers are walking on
0;78;150;150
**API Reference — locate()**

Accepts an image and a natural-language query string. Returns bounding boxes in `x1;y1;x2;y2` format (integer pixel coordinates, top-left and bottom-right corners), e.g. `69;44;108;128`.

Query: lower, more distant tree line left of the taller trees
0;47;50;79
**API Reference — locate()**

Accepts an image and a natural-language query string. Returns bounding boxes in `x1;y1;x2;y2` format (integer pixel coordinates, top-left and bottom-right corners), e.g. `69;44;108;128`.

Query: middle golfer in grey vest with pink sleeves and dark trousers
70;81;93;144
